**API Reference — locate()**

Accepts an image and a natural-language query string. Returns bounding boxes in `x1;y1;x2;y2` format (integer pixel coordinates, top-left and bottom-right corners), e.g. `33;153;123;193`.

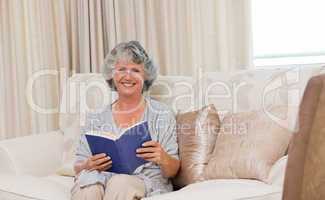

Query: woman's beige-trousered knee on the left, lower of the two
71;184;104;200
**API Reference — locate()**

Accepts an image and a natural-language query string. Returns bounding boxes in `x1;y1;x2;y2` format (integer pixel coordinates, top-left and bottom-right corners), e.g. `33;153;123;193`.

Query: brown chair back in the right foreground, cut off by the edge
283;75;325;200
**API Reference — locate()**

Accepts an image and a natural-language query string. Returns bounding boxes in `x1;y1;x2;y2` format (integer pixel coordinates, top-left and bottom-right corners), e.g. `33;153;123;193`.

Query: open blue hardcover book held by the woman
85;121;151;174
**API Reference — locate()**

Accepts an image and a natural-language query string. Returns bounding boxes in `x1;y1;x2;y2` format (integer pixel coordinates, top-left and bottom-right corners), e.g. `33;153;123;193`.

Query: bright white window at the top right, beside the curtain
252;0;325;66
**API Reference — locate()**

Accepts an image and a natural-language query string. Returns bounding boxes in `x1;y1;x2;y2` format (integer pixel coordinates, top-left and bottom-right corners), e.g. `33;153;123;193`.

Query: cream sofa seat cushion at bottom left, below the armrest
0;174;73;200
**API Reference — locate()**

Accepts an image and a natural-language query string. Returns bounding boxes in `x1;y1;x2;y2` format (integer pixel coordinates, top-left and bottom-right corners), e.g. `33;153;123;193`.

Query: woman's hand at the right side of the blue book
137;140;169;165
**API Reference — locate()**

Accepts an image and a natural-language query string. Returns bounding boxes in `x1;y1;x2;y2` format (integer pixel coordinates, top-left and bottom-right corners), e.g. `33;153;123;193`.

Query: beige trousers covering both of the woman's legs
71;174;145;200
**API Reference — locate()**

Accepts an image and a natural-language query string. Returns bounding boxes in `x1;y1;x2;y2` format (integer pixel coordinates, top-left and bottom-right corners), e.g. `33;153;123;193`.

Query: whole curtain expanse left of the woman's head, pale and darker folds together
0;0;115;139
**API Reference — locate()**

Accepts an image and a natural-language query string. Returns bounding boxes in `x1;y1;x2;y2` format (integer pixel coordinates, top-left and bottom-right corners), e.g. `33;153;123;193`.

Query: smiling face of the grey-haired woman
113;61;145;97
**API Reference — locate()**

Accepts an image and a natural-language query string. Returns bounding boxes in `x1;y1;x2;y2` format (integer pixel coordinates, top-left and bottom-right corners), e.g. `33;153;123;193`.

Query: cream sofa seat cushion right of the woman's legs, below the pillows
145;179;282;200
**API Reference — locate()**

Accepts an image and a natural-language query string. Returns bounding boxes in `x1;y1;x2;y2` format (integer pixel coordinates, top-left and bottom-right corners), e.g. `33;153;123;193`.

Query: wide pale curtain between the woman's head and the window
114;0;252;75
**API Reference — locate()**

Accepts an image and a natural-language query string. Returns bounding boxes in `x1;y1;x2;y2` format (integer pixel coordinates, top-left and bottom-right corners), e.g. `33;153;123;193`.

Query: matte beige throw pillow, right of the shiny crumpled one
204;107;296;182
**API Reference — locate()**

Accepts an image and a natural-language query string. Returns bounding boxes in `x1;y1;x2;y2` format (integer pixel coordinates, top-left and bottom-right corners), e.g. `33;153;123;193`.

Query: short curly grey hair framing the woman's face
103;41;158;91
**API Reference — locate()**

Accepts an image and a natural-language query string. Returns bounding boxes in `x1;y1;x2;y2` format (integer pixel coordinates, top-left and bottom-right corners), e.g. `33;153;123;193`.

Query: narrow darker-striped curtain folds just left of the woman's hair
71;0;116;72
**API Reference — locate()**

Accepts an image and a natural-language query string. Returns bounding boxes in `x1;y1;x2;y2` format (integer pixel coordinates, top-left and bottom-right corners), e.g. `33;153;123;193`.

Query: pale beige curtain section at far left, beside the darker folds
0;0;69;138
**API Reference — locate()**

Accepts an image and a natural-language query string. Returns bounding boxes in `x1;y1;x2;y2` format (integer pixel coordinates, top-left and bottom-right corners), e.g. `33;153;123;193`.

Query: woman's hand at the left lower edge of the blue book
85;153;112;171
